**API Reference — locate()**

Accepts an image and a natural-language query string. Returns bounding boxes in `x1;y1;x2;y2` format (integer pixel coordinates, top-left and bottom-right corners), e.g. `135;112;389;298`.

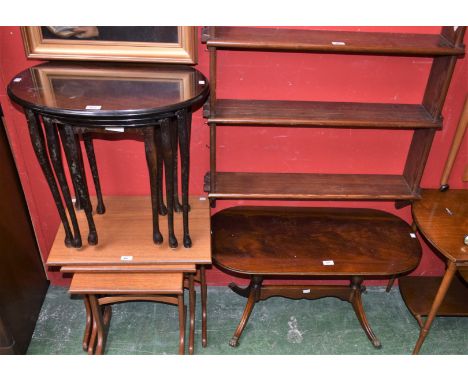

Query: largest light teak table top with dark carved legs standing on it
47;196;211;266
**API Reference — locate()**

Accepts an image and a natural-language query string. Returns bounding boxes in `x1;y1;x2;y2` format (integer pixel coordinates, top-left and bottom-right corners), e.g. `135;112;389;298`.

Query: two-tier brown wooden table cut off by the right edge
400;190;468;354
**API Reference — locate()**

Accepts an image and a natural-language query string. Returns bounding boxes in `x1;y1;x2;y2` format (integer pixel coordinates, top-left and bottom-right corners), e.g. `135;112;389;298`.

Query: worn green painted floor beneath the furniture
28;287;468;354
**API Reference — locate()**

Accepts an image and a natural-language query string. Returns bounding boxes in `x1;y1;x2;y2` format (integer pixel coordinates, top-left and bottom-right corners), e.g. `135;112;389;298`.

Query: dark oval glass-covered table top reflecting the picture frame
8;62;209;118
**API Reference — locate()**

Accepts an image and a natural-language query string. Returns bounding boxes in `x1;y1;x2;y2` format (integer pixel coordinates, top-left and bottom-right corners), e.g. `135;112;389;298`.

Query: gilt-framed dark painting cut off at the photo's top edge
21;26;197;64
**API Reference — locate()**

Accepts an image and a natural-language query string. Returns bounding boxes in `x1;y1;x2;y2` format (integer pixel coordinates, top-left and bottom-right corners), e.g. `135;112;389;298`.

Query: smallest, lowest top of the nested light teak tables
69;273;183;295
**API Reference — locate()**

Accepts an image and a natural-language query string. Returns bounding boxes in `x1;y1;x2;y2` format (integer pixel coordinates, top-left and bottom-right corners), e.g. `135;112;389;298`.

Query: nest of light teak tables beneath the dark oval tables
47;196;211;354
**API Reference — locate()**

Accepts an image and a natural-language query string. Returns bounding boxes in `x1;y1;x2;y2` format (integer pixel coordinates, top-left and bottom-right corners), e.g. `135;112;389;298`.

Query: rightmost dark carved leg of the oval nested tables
176;109;192;248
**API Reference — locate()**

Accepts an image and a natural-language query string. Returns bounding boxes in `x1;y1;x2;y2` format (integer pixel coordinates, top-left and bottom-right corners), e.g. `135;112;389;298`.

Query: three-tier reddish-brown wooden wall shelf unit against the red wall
202;27;465;201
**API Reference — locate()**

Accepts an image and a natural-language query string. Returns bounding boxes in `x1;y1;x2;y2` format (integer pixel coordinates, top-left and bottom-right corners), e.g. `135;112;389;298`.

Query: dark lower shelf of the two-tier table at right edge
399;276;468;316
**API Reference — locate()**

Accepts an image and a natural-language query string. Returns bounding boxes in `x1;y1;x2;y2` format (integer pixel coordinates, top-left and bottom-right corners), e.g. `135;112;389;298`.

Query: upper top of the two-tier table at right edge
413;189;468;262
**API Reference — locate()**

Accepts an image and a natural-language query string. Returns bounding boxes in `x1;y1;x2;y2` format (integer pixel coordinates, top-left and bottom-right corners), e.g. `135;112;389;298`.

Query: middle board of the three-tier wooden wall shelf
208;99;442;129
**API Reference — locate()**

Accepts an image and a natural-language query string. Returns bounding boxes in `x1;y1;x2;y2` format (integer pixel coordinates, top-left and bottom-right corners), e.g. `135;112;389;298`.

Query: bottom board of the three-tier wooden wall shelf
205;172;419;200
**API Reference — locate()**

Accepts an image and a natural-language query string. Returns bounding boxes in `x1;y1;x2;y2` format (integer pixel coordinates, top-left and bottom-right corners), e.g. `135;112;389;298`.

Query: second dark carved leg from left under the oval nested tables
42;117;81;247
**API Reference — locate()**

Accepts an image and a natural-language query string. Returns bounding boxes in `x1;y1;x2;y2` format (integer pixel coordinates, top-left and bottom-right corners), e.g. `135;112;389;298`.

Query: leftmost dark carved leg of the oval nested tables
25;109;73;247
